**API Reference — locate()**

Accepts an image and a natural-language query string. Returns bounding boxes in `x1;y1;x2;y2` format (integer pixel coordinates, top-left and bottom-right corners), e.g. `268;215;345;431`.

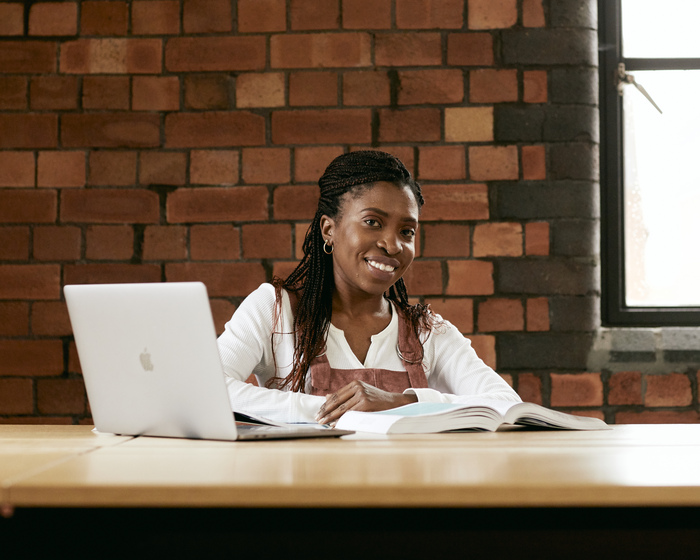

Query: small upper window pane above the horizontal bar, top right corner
621;0;700;58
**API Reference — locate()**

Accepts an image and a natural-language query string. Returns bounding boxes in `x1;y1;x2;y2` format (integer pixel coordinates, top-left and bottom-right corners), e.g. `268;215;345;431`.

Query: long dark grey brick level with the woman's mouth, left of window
496;259;600;295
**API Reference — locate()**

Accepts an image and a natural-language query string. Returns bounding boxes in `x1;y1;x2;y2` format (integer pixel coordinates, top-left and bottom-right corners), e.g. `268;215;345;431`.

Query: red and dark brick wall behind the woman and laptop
0;0;700;423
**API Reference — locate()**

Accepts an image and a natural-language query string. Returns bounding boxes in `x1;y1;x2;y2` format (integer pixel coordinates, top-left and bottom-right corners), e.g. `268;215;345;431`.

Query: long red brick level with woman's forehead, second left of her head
167;187;268;223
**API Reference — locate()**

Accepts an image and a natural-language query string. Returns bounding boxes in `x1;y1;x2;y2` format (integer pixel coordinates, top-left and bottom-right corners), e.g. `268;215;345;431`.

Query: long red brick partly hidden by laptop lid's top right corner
165;263;265;297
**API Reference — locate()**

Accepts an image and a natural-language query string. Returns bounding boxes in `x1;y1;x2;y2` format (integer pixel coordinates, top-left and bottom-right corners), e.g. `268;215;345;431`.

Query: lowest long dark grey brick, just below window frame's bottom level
496;333;593;371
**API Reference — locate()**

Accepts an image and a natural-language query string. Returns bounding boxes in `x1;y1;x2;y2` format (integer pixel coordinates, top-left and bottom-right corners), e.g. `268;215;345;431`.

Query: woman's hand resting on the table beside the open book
316;381;418;424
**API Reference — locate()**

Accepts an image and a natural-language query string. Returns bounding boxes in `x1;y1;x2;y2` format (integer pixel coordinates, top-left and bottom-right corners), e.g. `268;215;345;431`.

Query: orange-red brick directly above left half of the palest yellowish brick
398;69;464;105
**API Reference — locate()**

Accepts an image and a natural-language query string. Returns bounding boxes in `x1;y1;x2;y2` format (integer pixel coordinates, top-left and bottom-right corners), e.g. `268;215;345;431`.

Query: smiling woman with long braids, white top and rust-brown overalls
219;151;520;424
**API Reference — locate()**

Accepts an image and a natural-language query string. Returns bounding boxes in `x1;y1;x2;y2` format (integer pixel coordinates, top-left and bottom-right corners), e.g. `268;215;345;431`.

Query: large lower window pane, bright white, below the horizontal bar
624;70;700;307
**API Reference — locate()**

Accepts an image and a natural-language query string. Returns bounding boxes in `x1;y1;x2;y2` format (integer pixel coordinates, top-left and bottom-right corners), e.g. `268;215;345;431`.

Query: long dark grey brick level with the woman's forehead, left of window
491;181;600;219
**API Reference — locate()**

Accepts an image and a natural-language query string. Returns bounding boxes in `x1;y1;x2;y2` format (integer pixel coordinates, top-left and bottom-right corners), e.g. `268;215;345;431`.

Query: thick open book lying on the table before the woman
336;398;610;434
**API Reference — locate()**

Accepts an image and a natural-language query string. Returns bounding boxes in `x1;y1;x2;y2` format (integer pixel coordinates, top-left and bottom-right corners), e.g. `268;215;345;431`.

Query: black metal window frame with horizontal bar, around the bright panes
598;0;700;327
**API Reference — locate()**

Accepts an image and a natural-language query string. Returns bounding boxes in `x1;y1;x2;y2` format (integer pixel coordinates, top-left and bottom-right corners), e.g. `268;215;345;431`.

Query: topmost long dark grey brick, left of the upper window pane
501;28;598;66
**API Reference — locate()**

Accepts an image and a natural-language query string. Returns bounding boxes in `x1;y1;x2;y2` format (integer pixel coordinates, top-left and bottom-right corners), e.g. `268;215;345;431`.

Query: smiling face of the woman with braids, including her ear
321;182;418;295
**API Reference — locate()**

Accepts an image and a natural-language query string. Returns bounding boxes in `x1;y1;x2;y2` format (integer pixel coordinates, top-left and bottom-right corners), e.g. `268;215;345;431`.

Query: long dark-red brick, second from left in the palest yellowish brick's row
61;113;160;148
